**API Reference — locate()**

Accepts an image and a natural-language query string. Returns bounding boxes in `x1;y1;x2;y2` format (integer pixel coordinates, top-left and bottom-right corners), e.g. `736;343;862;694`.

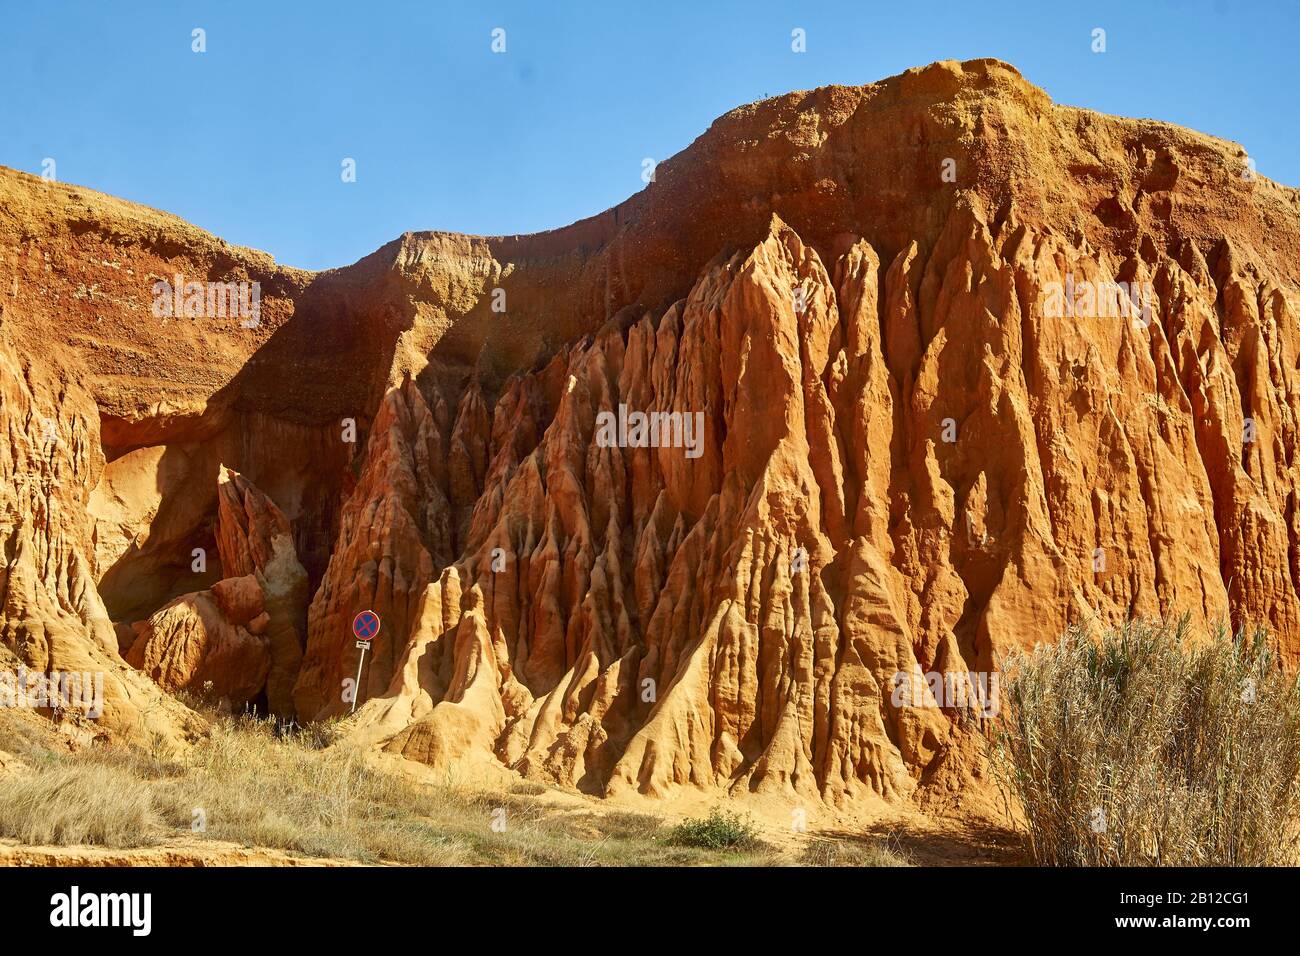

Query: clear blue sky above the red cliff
0;0;1300;268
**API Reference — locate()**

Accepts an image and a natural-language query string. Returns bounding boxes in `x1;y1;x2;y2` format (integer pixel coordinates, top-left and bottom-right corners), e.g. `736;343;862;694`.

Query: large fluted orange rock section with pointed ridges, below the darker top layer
340;196;1300;803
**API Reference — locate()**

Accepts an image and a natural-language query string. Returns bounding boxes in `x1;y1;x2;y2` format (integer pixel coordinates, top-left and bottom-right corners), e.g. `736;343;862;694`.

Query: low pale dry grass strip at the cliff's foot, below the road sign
0;711;873;866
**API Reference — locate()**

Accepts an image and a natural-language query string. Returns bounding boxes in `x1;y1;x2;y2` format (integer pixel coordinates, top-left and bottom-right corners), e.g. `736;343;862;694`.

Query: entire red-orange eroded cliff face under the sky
0;61;1300;804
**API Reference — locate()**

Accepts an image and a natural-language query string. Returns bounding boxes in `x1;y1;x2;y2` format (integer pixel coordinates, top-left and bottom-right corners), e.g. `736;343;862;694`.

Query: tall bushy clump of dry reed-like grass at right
992;620;1300;866
